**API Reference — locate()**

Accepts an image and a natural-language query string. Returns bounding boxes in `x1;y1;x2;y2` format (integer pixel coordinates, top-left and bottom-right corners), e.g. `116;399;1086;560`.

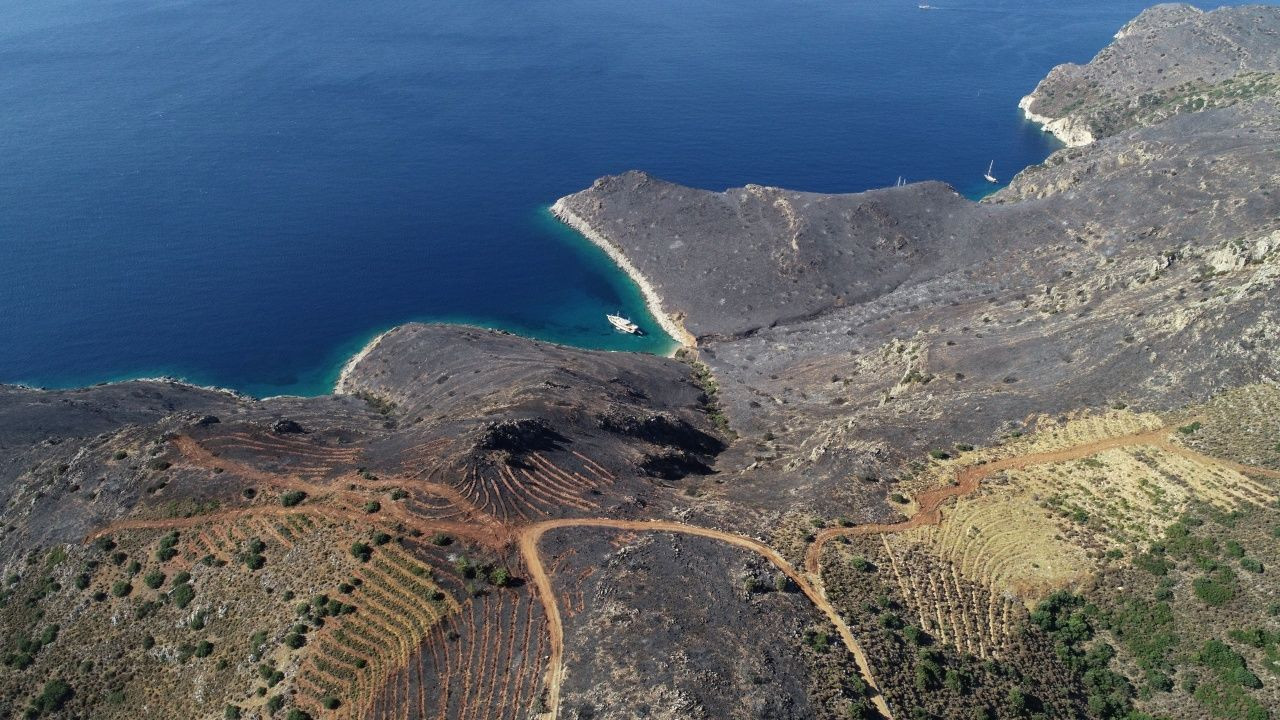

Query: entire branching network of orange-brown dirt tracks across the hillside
87;428;1280;720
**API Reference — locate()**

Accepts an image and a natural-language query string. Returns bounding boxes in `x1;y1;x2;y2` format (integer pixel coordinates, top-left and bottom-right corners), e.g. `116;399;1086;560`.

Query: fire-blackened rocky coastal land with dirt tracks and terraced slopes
0;5;1280;720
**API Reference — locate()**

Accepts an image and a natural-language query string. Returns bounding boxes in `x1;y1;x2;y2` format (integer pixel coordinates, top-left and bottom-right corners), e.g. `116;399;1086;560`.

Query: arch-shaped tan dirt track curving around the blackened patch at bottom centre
520;518;892;720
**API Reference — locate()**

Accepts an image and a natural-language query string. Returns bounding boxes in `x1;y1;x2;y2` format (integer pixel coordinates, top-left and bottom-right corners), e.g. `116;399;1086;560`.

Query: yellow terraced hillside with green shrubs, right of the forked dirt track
809;386;1280;717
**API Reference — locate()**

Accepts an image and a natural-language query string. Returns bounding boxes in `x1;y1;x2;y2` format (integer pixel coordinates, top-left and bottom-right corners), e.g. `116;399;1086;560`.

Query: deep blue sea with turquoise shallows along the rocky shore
0;0;1244;395
